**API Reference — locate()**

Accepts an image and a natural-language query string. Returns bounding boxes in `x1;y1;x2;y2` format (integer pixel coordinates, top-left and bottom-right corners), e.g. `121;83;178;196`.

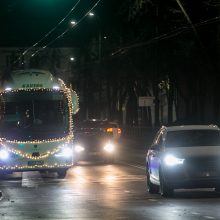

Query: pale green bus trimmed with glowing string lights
0;69;79;178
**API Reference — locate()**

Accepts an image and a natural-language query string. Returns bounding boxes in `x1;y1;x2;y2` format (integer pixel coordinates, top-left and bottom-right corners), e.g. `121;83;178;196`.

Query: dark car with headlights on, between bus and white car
74;119;121;163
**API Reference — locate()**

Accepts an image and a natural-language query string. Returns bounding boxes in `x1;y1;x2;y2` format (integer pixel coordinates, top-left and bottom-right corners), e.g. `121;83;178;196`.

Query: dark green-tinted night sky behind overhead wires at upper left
0;0;117;47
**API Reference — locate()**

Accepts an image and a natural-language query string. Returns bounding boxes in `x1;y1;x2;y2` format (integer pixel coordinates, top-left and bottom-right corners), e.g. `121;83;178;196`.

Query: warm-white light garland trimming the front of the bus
0;79;79;163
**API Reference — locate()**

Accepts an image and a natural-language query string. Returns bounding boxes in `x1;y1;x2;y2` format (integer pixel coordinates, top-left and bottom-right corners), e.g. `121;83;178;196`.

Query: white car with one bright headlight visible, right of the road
146;125;220;197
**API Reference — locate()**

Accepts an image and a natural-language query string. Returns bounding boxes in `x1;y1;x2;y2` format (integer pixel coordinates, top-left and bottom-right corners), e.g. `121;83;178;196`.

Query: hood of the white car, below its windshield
165;146;220;157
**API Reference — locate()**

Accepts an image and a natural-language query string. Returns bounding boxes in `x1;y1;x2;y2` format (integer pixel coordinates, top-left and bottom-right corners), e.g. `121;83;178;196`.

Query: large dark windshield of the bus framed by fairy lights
0;90;69;141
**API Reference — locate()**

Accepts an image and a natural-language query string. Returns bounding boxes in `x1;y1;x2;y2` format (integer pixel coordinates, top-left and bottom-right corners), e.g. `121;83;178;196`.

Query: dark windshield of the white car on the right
165;130;220;147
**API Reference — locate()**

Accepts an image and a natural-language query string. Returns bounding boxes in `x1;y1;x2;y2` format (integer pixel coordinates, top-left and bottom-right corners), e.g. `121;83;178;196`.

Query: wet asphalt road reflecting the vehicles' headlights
0;140;220;220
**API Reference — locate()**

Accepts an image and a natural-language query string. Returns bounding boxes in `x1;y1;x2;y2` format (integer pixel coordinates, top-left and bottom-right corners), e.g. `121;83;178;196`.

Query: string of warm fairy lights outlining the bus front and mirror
0;79;79;169
